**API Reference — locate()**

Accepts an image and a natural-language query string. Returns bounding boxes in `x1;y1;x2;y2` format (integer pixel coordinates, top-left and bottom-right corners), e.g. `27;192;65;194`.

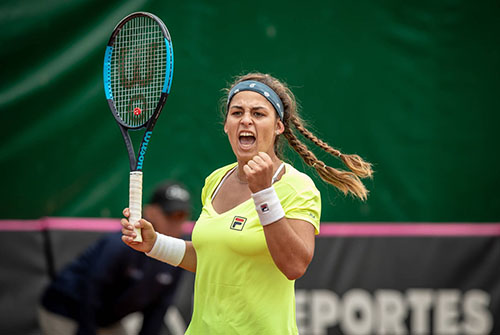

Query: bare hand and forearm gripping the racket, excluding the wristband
121;208;196;272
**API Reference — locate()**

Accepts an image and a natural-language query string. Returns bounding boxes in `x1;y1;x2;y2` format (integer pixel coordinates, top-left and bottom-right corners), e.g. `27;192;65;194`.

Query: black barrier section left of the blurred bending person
0;220;109;335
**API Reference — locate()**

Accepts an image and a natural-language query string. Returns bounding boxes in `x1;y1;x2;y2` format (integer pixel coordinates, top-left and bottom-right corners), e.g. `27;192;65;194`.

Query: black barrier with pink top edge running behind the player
0;219;500;335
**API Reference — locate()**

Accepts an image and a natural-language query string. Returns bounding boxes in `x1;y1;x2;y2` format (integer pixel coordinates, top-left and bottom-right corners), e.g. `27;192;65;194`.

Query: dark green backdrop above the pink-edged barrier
0;0;500;222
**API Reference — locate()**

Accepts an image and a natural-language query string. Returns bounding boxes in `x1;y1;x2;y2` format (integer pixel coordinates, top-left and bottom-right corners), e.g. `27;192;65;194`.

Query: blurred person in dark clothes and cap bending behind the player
39;181;190;335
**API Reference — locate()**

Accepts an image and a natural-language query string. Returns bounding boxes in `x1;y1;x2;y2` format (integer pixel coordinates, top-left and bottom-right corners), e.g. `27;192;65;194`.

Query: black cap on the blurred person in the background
150;181;191;213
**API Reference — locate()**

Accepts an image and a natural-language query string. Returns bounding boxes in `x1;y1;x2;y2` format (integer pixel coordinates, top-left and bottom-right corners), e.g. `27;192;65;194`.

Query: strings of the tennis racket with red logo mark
111;16;167;127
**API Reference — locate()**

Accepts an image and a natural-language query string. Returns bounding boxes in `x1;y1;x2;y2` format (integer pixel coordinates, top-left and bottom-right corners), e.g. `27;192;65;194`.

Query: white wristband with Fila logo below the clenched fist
252;186;285;226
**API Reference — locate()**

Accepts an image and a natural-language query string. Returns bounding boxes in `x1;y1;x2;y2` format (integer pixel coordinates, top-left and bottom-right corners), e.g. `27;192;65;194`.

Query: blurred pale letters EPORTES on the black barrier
295;288;493;335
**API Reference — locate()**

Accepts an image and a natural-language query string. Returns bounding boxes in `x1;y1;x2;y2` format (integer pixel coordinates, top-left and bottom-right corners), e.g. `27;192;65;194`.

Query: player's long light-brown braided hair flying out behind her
224;73;373;200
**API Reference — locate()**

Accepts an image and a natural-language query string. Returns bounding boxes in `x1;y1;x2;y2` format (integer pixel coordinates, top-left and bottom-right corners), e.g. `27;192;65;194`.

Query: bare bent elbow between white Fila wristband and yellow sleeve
264;217;314;280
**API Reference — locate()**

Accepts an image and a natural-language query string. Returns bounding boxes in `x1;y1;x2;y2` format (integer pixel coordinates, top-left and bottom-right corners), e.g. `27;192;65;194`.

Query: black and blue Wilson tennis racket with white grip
103;12;174;242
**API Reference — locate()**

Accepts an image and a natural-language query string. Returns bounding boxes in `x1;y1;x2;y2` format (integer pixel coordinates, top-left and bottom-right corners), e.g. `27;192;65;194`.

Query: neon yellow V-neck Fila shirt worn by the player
186;163;321;335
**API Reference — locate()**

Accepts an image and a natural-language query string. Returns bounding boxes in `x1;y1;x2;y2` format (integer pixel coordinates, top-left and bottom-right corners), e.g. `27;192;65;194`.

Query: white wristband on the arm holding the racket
146;232;186;266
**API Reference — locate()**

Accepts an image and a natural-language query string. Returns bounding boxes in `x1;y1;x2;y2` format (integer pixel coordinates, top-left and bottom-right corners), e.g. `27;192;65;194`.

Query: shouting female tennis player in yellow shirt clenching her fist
122;73;372;335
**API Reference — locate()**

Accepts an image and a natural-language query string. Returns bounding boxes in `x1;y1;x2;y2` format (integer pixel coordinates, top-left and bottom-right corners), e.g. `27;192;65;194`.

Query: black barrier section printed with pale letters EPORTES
296;237;500;335
